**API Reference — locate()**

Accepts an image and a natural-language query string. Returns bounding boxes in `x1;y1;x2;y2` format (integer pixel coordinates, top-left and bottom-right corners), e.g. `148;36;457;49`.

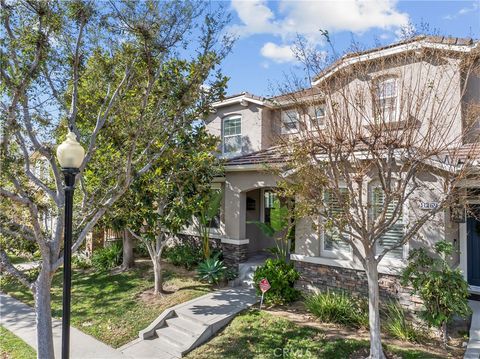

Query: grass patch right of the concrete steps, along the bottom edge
187;310;439;359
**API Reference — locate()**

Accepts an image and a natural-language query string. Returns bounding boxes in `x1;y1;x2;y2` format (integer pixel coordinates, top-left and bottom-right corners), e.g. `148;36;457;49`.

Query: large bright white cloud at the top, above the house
230;0;409;62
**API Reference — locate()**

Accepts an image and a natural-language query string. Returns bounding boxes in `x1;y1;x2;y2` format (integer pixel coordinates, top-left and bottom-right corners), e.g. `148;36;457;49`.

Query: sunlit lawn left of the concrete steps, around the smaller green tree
1;263;211;348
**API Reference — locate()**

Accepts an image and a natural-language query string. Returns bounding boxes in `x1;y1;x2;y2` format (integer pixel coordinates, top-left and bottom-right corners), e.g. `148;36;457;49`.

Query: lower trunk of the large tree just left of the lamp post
34;263;55;359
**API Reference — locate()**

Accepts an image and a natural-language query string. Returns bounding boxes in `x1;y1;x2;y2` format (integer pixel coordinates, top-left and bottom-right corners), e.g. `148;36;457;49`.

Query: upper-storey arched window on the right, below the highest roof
374;78;397;122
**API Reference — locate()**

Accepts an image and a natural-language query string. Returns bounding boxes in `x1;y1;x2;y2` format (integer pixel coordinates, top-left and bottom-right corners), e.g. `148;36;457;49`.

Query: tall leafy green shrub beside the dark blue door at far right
402;241;471;344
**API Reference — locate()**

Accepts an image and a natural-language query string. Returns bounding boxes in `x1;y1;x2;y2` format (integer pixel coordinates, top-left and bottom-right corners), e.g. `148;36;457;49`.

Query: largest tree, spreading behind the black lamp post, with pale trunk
0;0;231;359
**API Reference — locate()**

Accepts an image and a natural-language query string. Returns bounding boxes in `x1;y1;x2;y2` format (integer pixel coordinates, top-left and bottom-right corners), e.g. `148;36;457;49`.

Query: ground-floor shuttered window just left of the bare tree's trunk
323;188;350;252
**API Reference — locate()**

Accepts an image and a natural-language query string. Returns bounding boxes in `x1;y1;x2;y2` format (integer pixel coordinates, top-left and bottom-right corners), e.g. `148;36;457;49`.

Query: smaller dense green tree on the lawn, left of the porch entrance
120;127;220;295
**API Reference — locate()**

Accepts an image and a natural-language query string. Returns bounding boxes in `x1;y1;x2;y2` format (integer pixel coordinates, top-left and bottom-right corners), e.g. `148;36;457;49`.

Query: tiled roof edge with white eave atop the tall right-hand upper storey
312;35;479;86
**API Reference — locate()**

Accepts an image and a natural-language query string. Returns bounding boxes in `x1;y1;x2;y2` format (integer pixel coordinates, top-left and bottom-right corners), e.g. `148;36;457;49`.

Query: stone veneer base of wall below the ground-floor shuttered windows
294;261;422;314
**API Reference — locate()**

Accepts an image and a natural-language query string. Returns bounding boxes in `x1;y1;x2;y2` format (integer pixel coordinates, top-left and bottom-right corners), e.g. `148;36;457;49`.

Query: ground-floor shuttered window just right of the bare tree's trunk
371;187;405;259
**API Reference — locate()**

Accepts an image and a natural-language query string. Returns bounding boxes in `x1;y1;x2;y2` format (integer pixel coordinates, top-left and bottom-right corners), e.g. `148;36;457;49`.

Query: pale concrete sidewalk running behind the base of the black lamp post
0;292;130;359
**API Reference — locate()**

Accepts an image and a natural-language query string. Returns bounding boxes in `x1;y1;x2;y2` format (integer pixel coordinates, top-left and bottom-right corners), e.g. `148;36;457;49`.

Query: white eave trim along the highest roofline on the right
312;40;478;86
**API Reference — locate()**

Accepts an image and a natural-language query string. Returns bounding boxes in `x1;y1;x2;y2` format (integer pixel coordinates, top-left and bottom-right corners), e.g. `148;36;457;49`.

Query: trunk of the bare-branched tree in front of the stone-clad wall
366;258;385;359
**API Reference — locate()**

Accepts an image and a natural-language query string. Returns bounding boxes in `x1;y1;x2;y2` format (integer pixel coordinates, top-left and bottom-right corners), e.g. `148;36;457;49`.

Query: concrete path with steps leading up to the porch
119;287;258;359
